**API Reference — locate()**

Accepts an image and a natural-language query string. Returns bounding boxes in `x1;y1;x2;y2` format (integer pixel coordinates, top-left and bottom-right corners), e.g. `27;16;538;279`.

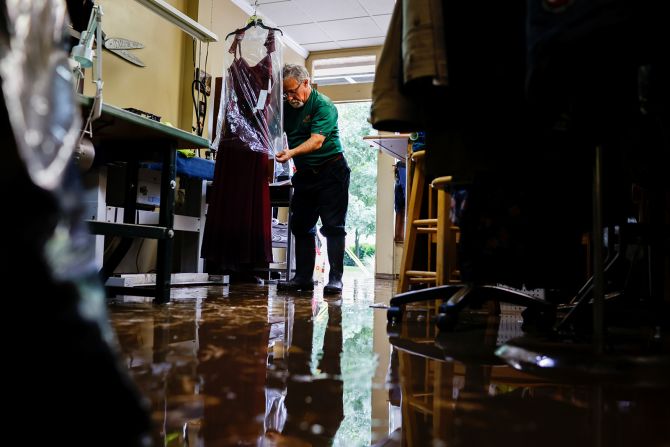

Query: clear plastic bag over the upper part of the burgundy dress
212;26;283;155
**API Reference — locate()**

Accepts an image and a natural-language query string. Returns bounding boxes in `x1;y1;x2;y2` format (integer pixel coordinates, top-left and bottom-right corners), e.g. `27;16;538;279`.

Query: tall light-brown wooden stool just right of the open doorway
398;151;458;293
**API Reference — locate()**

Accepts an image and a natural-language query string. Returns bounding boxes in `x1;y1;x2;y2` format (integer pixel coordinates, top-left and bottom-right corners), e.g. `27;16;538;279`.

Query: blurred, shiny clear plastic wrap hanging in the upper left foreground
0;0;81;190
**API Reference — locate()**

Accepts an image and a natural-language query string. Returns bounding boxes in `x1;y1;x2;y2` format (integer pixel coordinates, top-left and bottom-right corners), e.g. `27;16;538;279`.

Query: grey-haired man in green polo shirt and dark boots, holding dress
276;64;350;294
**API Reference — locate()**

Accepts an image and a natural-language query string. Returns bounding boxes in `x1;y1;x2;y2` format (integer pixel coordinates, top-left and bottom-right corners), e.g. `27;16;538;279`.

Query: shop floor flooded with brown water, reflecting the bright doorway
109;277;670;447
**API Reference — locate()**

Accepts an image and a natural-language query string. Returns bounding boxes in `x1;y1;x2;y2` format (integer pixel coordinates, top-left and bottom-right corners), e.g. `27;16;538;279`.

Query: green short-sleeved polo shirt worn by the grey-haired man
284;90;343;169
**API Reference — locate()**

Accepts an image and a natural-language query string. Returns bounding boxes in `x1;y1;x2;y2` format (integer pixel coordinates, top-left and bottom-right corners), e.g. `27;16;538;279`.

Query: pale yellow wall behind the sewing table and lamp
84;0;305;136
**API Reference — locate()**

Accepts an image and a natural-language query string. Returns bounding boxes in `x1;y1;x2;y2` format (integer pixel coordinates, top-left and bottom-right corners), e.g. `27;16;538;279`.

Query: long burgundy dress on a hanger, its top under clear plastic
202;30;279;272
